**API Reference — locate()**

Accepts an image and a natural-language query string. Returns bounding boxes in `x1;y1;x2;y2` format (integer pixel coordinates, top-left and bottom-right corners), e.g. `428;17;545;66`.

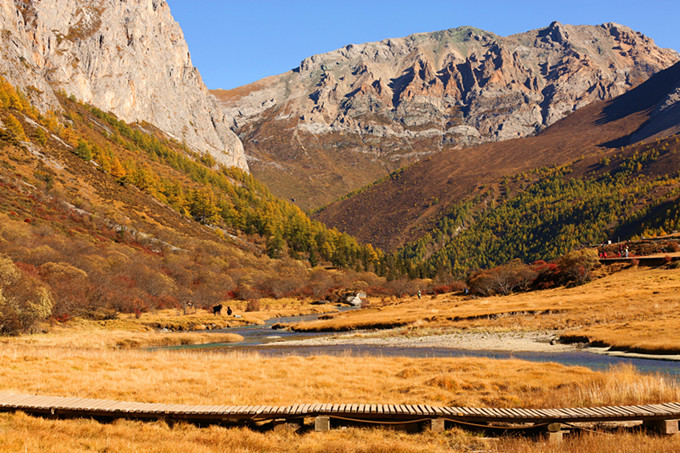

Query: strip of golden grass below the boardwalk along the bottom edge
0;414;680;453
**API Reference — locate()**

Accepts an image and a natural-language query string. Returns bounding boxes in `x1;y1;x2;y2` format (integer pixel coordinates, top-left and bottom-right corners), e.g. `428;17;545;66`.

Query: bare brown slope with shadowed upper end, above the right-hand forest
315;64;680;249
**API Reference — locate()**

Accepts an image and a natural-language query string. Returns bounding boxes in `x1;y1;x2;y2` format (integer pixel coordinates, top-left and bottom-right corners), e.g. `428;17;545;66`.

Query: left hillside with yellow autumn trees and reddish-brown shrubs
0;77;385;324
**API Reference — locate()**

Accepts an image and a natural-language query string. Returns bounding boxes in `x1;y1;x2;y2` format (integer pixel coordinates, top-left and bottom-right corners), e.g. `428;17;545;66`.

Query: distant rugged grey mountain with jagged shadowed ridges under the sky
215;22;678;208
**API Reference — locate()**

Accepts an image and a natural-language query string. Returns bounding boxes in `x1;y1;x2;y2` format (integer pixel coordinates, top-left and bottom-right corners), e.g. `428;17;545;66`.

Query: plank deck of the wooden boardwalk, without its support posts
0;393;680;424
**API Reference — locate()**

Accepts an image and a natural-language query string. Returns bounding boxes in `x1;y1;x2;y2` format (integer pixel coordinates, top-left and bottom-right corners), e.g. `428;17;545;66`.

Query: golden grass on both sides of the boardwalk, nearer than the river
0;344;680;452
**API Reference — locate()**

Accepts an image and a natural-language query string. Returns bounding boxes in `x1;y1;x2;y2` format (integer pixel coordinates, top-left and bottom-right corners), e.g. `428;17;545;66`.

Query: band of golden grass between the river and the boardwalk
0;345;680;407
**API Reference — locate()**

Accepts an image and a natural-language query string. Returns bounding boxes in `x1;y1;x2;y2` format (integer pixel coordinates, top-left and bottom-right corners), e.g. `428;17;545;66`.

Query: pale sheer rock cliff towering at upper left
0;0;248;170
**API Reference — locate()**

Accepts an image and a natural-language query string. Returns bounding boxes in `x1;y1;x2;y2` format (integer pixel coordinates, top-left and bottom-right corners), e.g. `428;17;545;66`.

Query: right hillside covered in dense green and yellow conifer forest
388;137;680;278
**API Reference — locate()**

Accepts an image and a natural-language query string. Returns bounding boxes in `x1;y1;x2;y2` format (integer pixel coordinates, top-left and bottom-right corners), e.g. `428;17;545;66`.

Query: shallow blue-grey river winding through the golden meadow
168;308;680;376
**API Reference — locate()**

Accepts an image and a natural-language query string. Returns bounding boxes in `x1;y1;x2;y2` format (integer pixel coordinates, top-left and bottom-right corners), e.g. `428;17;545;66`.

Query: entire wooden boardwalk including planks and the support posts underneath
0;393;680;438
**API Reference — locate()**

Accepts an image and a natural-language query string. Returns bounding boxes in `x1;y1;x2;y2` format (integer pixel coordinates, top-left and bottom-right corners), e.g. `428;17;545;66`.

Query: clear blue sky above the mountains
167;0;680;89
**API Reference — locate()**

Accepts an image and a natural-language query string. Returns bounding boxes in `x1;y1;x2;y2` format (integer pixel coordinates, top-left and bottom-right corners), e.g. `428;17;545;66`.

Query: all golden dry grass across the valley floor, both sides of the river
0;269;680;452
